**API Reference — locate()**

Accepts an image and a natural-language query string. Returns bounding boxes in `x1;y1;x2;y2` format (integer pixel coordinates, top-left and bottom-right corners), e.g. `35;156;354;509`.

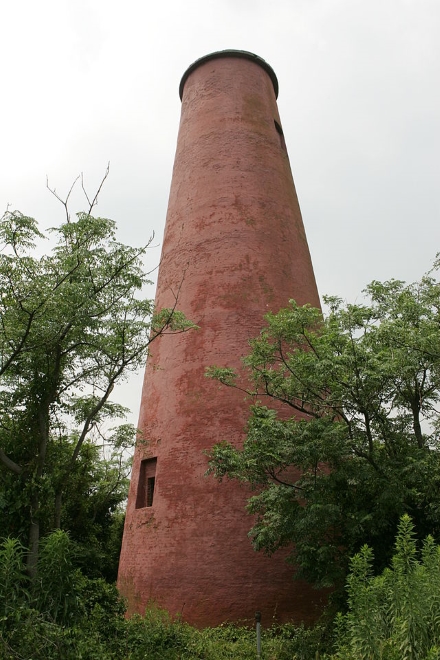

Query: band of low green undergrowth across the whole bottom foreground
0;516;440;660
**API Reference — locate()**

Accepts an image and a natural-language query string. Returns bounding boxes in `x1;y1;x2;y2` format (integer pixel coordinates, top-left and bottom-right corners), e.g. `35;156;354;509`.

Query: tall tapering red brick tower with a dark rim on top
119;50;319;626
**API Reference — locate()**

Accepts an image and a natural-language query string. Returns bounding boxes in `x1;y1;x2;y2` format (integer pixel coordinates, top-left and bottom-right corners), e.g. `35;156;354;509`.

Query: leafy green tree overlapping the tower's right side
208;262;440;586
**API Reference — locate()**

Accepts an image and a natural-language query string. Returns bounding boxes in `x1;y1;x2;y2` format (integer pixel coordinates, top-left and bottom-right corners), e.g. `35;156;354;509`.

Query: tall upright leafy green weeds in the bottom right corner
334;515;440;660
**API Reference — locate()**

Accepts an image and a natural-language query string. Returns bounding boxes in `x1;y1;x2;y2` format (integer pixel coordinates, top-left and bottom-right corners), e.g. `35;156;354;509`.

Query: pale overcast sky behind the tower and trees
0;0;440;414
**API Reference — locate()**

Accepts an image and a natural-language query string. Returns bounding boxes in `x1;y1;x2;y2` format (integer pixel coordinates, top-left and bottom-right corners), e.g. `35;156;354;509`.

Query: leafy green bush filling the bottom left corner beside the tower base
0;530;125;660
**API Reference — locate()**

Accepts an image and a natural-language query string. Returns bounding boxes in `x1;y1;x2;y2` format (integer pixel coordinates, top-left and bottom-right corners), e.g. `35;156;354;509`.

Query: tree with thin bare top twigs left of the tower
0;182;193;574
